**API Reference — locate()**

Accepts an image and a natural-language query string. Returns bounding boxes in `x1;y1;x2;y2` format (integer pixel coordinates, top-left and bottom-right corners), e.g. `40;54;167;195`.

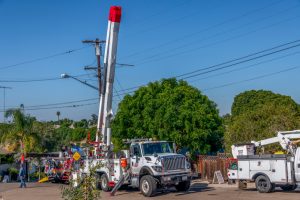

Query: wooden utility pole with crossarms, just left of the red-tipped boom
82;38;106;142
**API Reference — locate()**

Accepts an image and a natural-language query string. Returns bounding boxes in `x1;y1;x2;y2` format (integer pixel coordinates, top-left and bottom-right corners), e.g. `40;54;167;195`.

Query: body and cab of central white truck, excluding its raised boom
85;140;191;197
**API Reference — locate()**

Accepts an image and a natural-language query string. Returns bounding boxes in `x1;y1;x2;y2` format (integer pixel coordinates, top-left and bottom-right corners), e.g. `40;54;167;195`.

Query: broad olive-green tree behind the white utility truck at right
225;90;300;150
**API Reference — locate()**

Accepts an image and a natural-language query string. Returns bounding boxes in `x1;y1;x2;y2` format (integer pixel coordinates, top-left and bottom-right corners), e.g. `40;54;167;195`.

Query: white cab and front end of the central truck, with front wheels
130;141;191;196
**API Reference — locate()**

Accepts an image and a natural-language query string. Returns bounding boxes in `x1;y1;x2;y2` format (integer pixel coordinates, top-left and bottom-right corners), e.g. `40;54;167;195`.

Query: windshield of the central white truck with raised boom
142;142;173;156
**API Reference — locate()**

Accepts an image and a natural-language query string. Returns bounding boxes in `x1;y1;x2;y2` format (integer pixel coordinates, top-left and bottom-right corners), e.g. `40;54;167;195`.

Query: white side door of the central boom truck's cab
130;144;142;175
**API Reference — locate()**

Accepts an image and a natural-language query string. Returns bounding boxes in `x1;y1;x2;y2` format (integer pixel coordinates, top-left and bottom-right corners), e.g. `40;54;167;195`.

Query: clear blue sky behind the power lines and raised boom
0;0;300;121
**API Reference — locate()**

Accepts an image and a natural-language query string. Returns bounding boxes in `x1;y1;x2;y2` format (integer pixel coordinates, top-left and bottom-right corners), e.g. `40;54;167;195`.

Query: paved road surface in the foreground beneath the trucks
0;182;300;200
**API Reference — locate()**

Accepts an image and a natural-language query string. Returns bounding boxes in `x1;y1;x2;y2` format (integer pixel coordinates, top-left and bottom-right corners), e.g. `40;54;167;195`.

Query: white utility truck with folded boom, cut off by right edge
228;130;300;193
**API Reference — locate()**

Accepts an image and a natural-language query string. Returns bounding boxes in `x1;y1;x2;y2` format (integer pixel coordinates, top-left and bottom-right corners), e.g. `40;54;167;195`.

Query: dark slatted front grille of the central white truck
162;156;185;170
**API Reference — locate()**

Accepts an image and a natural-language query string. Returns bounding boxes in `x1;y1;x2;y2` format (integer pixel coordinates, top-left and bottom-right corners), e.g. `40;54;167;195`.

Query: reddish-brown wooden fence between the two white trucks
197;153;232;181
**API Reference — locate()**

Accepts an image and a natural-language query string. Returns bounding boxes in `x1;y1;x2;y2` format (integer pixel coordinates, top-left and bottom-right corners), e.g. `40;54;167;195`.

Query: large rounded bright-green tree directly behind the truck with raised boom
112;79;223;153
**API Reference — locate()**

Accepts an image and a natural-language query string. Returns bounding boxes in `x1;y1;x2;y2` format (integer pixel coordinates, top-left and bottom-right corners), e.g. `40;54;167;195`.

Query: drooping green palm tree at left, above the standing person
4;109;39;153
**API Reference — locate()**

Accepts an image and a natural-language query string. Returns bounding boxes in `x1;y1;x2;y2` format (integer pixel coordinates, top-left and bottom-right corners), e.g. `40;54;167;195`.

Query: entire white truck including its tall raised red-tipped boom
74;6;191;196
